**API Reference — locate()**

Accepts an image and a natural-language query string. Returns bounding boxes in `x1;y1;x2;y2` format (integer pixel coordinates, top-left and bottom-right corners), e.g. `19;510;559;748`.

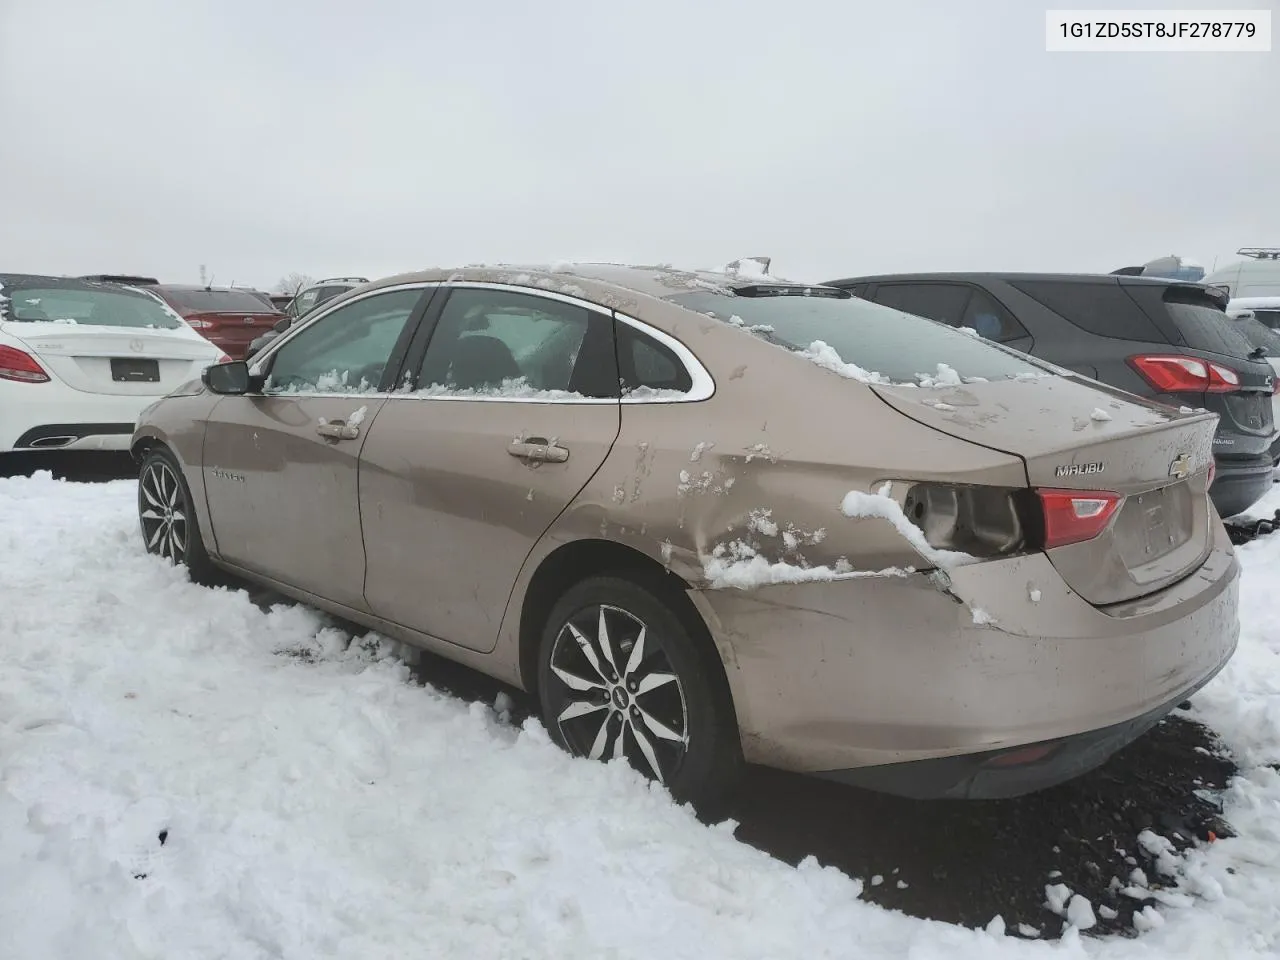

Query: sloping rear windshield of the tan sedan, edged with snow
669;291;1047;384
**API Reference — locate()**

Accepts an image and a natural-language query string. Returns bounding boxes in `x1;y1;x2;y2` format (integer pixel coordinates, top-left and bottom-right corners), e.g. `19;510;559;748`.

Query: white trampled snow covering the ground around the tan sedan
0;476;1280;960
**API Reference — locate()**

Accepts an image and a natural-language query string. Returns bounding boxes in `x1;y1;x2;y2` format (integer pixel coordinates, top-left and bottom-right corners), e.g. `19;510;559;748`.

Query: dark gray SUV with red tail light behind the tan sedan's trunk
831;273;1280;517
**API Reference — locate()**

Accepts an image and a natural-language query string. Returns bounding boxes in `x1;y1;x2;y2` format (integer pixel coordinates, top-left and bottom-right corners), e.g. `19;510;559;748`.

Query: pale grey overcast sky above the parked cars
0;0;1280;288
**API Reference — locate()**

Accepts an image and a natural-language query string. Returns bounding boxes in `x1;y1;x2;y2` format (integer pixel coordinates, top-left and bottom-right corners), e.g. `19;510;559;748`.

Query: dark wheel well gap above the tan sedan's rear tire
520;540;712;696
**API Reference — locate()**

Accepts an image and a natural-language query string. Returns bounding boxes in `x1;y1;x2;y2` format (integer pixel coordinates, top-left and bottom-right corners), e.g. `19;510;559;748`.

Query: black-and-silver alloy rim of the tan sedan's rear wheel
548;604;689;783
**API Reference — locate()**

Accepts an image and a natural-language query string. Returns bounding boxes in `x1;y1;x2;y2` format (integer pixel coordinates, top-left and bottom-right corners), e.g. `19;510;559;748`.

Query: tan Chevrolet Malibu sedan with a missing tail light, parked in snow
133;265;1239;803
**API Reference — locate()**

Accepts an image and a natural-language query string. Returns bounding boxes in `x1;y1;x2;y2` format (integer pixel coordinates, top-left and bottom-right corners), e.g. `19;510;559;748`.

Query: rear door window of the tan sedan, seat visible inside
411;287;618;399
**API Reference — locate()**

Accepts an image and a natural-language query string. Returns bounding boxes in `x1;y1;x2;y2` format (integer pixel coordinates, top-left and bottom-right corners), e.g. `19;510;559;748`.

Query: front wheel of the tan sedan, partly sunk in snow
138;447;221;585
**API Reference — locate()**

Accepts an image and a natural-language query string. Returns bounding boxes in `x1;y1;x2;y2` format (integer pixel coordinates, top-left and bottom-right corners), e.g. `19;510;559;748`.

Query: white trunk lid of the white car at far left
0;323;218;397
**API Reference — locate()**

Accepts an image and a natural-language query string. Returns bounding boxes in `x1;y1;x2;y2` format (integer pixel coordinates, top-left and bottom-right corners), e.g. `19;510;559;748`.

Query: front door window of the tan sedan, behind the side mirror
266;289;422;394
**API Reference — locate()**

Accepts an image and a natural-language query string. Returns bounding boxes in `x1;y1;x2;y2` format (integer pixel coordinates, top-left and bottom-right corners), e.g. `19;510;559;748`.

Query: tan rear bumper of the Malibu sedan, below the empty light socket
690;524;1239;788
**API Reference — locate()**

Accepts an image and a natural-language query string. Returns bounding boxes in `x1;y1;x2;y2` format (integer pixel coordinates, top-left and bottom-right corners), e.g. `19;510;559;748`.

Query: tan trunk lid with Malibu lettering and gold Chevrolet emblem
872;376;1217;605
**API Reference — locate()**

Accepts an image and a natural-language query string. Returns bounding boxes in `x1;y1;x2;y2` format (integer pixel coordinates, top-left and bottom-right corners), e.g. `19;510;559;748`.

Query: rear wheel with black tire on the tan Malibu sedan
538;576;742;813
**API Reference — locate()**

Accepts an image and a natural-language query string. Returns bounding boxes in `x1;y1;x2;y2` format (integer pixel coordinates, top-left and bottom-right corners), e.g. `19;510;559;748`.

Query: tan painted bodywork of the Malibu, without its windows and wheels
134;265;1238;798
